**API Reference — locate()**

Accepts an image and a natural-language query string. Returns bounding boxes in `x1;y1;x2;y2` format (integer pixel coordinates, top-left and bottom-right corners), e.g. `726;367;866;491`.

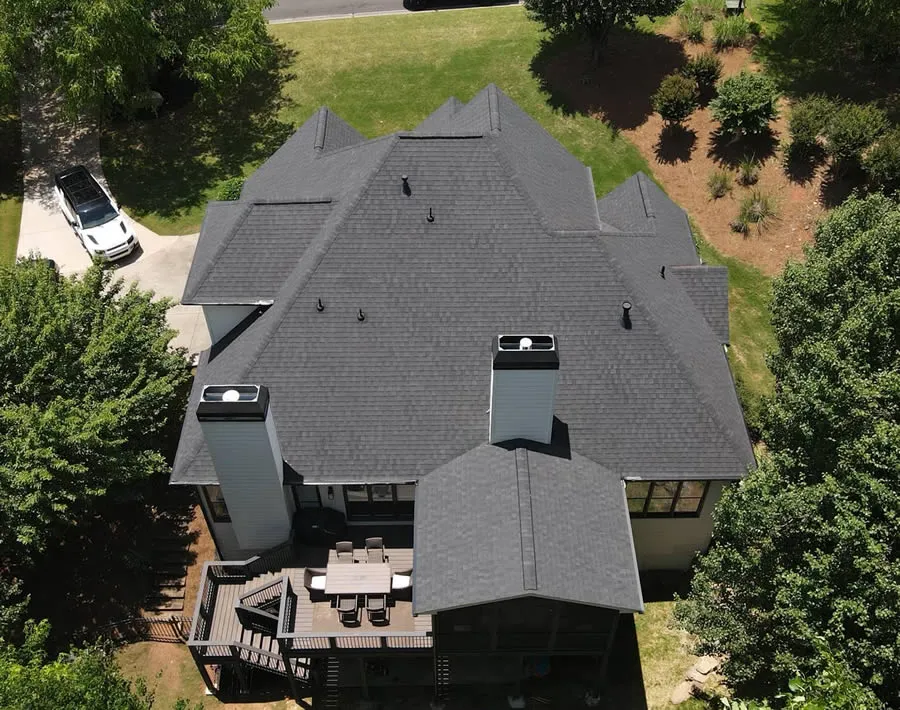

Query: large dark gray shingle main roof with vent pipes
172;89;754;492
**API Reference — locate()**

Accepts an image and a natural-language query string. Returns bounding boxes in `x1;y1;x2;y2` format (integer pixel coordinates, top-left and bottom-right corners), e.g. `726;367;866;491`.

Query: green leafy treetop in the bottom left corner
0;621;202;710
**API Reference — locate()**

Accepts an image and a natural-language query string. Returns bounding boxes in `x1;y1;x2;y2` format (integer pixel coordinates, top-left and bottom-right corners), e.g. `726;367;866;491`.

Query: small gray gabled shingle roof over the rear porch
413;442;643;613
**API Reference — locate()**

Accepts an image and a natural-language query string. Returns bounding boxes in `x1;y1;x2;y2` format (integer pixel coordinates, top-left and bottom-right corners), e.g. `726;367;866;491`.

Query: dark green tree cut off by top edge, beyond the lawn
525;0;681;62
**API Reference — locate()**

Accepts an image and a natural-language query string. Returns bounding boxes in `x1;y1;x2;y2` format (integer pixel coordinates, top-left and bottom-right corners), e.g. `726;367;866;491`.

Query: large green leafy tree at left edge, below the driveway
0;259;190;569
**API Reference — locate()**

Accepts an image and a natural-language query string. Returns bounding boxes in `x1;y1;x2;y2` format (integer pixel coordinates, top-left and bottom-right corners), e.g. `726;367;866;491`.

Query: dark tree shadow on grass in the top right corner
755;2;900;102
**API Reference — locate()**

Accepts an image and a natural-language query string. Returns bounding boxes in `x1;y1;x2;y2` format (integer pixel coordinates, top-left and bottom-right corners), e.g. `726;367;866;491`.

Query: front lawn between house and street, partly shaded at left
101;6;651;234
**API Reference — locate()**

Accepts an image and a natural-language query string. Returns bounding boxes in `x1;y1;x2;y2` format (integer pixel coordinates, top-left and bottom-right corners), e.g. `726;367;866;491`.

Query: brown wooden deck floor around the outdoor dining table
206;548;431;652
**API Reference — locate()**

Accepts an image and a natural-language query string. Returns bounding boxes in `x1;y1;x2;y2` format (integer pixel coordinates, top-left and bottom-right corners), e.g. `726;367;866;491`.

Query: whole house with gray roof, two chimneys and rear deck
172;85;754;699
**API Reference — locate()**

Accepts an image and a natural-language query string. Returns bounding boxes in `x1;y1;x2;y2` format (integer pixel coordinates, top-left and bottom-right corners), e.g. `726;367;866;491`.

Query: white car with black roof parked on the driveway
54;165;138;261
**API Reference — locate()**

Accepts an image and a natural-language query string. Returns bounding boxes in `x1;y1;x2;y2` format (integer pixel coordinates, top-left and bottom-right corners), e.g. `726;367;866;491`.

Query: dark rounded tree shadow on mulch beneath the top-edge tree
530;28;687;130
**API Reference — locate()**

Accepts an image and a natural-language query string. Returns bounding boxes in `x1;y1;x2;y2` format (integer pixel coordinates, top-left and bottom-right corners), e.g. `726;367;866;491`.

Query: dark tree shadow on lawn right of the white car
101;40;295;227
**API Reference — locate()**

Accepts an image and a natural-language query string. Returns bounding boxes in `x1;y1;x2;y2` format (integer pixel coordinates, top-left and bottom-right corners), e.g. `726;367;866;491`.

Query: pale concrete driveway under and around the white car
16;86;209;354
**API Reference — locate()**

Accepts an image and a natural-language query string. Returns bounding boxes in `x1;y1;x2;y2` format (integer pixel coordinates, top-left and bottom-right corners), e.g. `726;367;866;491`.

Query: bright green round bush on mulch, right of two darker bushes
710;71;778;135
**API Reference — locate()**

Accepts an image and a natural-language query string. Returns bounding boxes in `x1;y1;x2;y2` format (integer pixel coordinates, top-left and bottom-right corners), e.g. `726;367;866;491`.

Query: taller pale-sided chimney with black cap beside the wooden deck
197;385;291;551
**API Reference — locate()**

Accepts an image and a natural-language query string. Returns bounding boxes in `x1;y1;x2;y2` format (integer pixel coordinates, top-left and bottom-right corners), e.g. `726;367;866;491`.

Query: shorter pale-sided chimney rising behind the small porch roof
490;335;559;444
